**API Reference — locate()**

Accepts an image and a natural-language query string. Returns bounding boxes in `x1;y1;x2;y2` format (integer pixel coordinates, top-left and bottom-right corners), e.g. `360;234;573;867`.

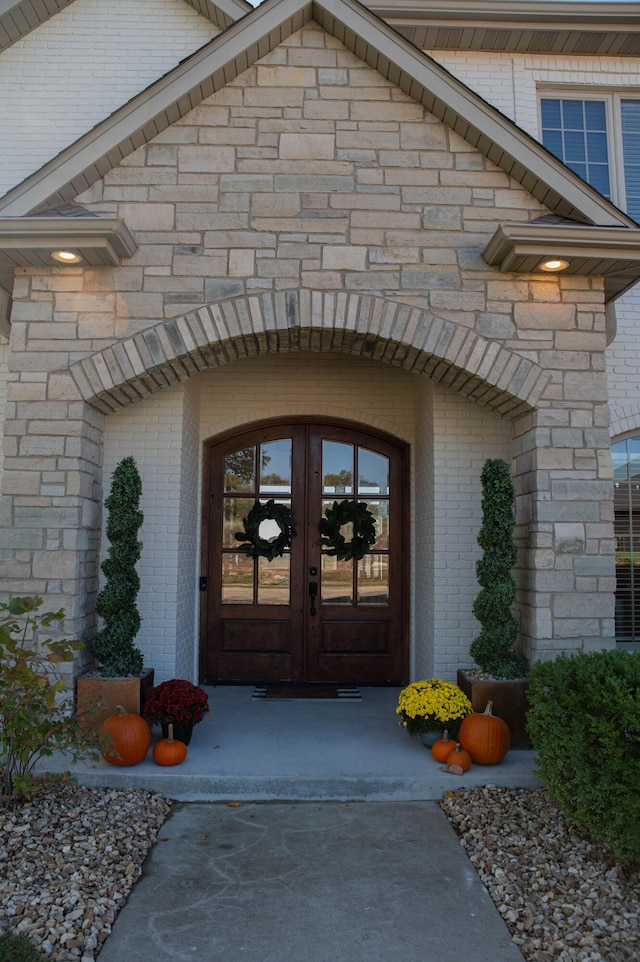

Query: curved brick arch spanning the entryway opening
70;289;550;417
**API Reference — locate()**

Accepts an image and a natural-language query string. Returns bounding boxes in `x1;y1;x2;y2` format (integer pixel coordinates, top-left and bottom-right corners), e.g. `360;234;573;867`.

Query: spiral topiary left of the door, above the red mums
91;457;144;678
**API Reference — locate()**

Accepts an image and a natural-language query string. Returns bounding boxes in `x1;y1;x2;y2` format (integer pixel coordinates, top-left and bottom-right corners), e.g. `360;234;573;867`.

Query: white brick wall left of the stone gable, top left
0;0;217;194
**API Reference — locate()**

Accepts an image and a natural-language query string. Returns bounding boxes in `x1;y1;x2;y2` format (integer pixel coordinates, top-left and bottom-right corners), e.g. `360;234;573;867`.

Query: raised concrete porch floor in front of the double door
40;686;542;801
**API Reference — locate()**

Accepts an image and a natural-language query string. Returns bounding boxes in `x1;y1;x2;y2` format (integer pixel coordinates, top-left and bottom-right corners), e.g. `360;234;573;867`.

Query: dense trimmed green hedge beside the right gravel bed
527;650;640;861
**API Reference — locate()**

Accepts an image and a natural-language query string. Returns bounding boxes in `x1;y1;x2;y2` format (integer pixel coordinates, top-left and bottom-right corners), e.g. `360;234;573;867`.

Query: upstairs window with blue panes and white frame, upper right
540;94;640;221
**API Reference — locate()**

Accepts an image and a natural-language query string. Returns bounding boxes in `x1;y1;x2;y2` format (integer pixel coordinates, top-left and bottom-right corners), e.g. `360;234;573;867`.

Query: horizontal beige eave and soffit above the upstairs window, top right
368;0;640;57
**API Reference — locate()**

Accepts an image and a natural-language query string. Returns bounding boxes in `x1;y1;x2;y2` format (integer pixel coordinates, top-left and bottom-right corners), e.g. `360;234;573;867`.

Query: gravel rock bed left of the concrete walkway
0;786;172;962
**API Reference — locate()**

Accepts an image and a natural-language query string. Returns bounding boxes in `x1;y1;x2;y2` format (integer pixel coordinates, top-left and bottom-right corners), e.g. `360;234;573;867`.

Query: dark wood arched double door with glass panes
201;420;407;684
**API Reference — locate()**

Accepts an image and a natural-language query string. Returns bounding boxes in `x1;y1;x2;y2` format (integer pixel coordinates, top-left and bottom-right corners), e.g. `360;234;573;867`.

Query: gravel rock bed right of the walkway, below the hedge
441;786;640;962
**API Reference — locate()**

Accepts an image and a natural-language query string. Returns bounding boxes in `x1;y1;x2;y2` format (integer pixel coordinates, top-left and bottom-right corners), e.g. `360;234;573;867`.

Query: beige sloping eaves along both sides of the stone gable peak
0;0;635;227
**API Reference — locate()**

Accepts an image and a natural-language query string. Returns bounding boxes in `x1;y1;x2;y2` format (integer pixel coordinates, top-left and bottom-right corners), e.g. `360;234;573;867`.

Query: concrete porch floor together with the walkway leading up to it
52;687;540;962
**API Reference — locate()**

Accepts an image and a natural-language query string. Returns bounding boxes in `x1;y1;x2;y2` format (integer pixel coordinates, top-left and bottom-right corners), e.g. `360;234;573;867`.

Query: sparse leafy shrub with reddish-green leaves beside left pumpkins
0;597;99;807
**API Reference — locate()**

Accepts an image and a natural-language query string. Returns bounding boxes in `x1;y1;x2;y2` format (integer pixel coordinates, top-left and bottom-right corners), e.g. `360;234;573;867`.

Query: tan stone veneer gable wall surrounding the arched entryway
0;25;613;676
